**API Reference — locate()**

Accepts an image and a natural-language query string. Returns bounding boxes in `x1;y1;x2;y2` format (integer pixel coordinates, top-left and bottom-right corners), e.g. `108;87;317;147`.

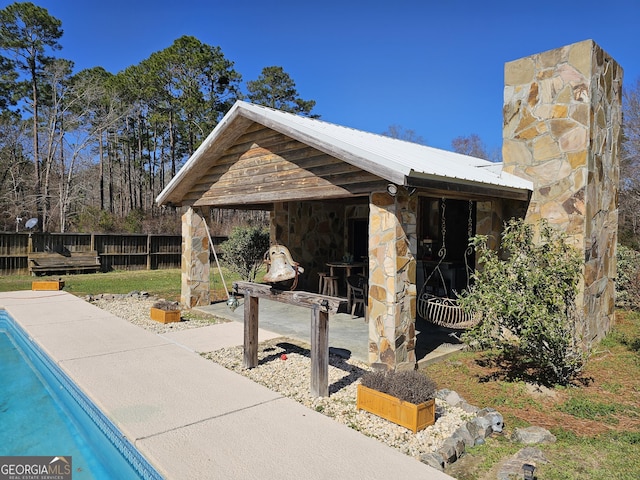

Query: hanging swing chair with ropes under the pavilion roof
417;198;479;330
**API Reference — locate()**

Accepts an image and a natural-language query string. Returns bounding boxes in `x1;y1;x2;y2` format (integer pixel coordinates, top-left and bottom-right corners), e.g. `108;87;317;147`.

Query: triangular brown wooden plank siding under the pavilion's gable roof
185;124;385;206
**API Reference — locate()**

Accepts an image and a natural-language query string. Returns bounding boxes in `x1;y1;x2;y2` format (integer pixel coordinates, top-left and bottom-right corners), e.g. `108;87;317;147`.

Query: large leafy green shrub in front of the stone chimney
460;220;586;385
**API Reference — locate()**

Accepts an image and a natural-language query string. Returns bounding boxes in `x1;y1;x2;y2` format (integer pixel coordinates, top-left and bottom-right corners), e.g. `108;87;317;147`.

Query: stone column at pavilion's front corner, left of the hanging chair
368;188;418;370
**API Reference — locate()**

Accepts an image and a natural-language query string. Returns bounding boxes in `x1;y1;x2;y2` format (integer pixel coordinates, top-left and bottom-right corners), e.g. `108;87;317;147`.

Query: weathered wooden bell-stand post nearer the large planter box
311;305;329;397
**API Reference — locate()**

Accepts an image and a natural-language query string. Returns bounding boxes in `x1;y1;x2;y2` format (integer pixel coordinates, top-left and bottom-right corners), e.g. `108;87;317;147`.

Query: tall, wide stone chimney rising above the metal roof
503;40;622;345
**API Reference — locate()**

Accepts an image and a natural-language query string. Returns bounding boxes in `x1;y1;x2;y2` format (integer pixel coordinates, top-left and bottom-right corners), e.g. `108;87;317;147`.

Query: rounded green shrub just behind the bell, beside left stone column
220;227;269;281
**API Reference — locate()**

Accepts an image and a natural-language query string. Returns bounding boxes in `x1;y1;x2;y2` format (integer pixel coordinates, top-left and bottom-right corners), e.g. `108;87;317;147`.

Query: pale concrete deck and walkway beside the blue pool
0;291;452;480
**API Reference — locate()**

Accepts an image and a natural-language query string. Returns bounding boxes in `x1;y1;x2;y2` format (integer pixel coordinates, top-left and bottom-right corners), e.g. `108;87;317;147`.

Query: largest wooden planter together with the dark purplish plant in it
356;370;436;433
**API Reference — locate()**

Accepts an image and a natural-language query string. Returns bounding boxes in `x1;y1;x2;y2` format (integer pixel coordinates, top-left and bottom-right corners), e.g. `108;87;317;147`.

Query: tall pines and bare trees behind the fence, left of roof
0;2;317;232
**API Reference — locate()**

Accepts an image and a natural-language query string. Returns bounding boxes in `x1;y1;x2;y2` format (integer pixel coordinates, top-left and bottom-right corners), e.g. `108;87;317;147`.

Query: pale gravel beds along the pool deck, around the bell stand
94;294;474;458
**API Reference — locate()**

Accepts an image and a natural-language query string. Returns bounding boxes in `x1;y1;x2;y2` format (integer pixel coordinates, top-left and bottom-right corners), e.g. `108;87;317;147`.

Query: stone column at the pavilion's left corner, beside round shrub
180;207;211;308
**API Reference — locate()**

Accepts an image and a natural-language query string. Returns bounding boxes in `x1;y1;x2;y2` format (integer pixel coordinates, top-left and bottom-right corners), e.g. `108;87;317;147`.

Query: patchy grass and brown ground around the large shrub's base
426;311;640;480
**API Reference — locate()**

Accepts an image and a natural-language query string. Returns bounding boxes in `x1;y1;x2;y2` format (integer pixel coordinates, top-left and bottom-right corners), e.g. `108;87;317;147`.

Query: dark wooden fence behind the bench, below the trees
0;232;226;275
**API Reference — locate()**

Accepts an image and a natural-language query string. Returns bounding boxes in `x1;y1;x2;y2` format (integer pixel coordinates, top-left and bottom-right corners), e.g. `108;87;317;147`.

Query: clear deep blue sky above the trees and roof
5;0;640;151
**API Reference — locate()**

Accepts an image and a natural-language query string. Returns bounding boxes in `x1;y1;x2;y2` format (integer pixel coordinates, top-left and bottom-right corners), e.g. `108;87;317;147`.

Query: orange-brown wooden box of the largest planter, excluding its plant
356;385;436;433
